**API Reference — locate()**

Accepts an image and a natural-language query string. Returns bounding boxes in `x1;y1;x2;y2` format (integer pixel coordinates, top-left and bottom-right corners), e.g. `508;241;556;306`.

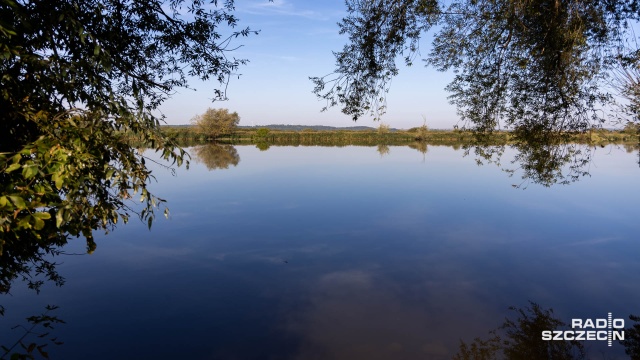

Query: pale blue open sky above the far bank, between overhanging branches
161;0;458;129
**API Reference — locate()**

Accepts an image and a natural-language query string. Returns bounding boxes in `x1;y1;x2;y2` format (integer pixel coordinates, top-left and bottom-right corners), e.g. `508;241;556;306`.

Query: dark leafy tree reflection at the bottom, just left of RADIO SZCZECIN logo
453;303;585;360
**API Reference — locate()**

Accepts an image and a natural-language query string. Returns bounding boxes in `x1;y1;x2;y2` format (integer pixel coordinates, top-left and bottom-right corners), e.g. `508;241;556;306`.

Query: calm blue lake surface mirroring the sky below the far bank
0;146;640;359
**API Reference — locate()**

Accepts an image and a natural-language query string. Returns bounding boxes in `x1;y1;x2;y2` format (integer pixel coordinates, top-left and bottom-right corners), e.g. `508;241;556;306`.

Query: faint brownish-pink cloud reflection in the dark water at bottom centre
287;269;487;360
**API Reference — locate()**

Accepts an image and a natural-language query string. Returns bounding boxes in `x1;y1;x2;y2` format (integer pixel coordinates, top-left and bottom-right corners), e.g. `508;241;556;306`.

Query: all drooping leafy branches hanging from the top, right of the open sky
311;0;640;133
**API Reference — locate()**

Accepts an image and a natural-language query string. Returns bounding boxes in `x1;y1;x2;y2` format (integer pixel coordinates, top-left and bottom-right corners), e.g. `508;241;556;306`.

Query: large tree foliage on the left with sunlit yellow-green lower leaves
0;0;255;292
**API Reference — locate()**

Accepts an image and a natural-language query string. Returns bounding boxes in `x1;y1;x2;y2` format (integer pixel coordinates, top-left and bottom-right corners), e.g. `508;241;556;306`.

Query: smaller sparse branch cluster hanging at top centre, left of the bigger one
311;0;439;120
